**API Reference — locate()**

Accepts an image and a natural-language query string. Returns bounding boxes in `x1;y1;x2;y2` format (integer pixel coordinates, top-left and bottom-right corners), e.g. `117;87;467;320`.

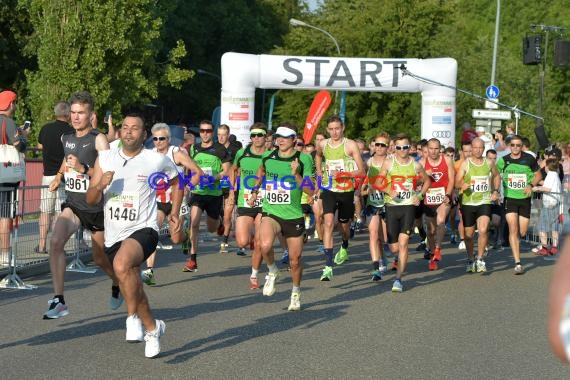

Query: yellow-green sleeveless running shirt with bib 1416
461;158;491;206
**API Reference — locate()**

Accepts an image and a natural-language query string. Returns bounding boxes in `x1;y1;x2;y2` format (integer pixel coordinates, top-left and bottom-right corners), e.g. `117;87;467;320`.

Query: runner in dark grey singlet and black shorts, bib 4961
44;92;118;319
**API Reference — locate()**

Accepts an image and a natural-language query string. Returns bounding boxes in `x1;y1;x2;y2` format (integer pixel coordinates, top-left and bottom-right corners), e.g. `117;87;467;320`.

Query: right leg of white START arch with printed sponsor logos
422;95;455;147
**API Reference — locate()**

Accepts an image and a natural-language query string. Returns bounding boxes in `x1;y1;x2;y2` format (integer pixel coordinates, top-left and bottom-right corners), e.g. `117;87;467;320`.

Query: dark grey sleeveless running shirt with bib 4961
61;131;103;212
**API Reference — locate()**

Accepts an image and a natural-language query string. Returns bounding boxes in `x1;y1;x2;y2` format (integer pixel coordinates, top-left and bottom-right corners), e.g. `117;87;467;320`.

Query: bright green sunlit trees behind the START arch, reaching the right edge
273;0;570;147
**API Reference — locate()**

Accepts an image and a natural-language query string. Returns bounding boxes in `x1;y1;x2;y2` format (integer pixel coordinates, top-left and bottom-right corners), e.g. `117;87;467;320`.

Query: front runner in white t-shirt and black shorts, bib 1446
87;114;184;358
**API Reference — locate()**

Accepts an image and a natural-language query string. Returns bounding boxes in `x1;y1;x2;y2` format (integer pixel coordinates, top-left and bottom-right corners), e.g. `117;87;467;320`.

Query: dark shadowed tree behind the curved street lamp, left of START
159;0;296;121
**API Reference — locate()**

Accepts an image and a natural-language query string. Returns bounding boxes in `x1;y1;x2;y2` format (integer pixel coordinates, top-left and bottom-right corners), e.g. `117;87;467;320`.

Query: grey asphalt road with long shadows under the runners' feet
0;229;570;379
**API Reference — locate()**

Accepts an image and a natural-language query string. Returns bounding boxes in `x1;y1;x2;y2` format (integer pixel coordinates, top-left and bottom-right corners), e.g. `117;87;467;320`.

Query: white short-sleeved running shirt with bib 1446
99;149;178;247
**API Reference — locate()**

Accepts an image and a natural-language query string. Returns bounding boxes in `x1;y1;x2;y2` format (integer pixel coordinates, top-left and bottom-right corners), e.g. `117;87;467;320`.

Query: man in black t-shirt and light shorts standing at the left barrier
35;102;74;253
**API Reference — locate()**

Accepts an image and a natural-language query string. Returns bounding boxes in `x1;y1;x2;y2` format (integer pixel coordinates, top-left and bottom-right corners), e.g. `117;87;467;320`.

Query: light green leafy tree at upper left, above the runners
20;0;191;129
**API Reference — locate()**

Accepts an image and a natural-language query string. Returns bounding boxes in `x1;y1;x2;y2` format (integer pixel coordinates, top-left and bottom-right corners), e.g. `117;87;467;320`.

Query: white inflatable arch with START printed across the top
221;53;457;146
